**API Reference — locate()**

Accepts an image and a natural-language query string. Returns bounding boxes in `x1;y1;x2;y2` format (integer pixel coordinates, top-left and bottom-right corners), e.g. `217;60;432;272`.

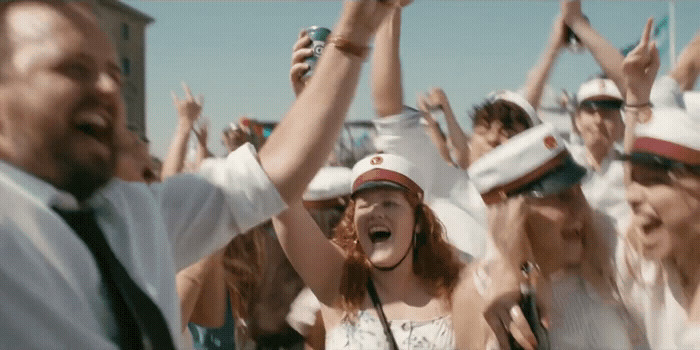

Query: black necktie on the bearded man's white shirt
54;208;175;349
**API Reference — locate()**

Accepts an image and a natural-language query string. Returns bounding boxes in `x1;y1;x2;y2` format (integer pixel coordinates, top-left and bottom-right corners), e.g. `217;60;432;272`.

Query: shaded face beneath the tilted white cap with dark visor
527;185;588;273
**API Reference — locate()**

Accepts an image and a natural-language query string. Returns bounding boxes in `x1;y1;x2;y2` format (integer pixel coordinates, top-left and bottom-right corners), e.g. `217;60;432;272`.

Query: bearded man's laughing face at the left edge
0;3;125;200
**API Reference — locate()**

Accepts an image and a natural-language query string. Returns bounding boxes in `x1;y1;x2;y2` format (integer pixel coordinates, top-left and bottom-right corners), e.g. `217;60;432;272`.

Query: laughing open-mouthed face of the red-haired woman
353;188;415;268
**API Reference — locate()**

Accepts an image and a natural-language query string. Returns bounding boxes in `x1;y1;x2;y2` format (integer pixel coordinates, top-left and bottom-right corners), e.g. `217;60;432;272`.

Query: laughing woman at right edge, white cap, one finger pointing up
616;19;700;349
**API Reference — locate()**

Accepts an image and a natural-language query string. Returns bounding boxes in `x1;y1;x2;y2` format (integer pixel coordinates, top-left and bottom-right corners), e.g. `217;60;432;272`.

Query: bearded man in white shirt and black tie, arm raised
0;0;391;349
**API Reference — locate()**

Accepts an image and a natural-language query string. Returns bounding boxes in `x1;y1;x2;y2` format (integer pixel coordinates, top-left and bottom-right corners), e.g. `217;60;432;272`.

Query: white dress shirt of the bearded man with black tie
0;145;286;349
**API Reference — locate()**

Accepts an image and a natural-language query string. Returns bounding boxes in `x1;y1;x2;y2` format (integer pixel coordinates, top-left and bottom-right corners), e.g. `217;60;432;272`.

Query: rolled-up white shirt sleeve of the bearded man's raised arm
154;144;287;271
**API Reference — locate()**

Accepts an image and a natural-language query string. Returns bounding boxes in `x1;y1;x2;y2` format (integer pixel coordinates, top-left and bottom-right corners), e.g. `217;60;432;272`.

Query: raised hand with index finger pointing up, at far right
622;18;661;106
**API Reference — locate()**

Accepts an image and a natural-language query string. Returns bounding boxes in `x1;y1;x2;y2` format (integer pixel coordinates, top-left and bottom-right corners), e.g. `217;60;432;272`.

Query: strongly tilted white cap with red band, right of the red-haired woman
468;123;586;205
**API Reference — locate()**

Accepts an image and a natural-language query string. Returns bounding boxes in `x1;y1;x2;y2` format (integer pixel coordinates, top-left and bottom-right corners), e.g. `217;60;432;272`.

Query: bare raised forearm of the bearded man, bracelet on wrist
258;0;395;203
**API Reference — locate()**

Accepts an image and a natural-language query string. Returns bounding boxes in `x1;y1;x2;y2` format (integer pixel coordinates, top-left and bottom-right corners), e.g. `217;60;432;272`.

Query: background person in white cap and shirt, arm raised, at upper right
544;0;630;243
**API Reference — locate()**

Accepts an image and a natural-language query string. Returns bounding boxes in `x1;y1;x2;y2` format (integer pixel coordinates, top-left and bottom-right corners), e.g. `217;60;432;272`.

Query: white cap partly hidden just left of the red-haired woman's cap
302;166;352;209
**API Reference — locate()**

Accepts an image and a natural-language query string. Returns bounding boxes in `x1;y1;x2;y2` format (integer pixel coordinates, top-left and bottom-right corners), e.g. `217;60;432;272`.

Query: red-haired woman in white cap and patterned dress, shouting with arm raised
274;154;463;349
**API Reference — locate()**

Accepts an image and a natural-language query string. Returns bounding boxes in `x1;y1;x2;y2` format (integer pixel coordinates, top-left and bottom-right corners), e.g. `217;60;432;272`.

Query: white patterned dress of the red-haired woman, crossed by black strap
326;310;455;350
